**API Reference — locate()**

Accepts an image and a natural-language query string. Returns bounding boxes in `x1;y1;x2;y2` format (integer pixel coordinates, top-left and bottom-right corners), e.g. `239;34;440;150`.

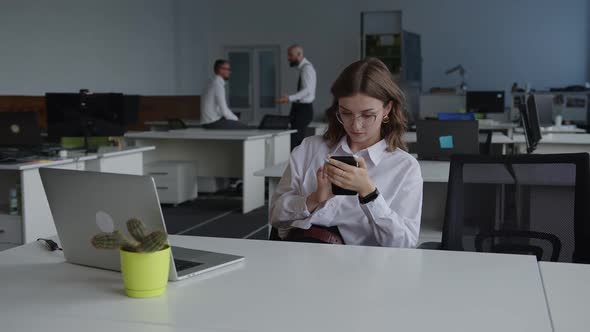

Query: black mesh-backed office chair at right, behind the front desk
419;153;590;263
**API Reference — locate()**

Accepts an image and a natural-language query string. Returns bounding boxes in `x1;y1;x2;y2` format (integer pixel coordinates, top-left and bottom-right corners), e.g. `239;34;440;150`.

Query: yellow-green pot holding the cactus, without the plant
120;247;170;298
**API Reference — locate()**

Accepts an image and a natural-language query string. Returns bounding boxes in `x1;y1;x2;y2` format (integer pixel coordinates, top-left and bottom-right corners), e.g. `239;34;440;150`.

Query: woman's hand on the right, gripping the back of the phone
326;157;375;197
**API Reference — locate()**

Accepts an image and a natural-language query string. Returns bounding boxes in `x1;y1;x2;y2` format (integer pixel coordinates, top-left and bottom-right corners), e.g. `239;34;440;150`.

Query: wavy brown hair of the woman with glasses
324;58;408;152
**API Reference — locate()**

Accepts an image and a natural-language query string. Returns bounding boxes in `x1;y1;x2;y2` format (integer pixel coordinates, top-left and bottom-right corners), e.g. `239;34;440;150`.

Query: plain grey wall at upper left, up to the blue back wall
0;0;206;95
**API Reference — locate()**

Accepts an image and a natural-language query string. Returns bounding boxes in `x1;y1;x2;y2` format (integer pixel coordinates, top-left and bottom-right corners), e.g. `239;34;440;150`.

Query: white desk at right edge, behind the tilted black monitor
514;134;590;153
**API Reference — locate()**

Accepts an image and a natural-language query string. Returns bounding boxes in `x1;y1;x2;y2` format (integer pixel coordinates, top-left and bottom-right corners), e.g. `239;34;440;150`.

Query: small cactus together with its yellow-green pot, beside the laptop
91;218;170;298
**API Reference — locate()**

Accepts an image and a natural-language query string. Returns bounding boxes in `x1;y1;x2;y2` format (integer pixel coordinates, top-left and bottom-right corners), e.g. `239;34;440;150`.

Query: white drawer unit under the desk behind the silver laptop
145;161;197;205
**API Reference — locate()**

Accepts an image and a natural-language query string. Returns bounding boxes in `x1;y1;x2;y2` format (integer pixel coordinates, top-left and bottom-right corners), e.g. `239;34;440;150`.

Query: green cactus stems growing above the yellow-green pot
91;218;168;252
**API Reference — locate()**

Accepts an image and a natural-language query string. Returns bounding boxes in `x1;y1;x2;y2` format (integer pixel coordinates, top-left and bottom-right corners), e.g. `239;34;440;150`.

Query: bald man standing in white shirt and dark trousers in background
279;45;317;149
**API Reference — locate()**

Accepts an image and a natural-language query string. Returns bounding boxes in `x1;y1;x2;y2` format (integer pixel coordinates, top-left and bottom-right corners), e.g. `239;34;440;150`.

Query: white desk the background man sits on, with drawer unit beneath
125;128;294;213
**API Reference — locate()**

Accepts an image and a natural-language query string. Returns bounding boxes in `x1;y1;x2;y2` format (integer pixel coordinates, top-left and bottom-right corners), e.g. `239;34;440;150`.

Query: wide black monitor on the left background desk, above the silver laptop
45;93;125;137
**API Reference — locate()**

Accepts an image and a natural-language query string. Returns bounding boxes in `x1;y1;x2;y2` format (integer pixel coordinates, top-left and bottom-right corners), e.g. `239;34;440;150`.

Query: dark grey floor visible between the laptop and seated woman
162;194;268;240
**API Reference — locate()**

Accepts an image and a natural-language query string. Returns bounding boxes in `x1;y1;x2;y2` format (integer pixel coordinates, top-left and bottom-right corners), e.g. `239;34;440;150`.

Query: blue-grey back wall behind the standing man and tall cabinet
208;0;590;114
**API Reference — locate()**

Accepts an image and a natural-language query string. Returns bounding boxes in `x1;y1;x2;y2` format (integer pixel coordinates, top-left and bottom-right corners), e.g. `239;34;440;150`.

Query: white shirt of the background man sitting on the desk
201;75;238;124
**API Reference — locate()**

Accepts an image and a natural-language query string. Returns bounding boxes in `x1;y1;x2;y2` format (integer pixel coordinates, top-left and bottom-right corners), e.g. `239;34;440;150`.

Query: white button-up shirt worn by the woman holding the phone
270;136;422;247
